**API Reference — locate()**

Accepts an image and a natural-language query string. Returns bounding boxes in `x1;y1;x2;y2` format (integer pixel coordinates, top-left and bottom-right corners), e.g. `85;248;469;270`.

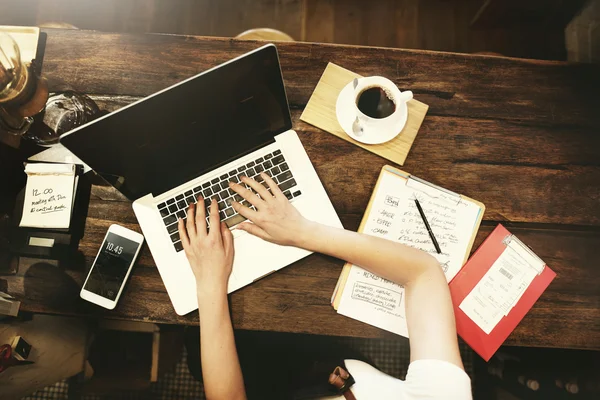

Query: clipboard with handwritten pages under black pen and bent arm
331;165;485;337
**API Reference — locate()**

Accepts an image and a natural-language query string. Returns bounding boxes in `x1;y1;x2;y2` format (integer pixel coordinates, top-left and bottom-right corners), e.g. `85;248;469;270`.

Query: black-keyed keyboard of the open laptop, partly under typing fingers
157;150;302;252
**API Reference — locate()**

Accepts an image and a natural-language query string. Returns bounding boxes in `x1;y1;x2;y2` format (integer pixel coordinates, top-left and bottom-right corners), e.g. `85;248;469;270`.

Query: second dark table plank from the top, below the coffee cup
93;97;600;226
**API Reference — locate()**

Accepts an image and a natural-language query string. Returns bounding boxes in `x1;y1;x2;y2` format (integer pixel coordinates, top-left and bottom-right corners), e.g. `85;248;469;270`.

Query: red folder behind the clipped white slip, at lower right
450;225;556;361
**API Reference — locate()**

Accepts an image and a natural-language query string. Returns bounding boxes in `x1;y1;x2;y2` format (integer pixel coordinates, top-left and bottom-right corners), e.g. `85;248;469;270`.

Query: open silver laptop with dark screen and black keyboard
60;44;342;315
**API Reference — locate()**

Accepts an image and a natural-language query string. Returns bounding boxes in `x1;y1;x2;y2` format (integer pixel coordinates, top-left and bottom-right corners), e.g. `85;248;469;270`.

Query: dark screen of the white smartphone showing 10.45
84;232;140;300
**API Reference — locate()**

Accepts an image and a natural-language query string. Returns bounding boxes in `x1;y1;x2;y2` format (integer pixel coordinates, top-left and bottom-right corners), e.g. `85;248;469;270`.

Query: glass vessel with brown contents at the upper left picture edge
0;32;48;135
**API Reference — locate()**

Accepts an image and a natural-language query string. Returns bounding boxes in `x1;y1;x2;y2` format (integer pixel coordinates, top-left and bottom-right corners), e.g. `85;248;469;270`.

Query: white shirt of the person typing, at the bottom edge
318;360;473;400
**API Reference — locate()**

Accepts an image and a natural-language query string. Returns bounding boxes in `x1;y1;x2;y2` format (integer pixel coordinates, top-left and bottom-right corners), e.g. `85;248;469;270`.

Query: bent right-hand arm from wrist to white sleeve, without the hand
296;223;463;368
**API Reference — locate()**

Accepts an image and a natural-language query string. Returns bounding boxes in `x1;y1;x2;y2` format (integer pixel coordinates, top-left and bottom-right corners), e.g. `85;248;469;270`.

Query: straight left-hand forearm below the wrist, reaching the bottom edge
198;290;246;400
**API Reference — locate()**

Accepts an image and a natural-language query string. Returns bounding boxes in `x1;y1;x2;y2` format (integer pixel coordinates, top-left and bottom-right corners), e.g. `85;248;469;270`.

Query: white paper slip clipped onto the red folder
459;238;544;335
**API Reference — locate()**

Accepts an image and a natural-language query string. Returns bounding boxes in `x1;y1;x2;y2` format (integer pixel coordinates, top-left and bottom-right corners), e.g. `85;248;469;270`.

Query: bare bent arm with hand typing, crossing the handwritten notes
231;173;462;367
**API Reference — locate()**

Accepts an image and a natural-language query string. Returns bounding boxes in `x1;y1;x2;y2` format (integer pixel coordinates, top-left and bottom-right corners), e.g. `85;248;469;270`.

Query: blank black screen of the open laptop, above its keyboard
61;45;292;200
